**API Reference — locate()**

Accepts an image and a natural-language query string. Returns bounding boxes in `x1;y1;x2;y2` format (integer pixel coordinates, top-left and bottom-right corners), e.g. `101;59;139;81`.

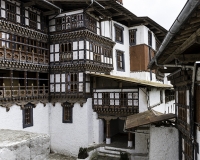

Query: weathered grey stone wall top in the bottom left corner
0;129;50;160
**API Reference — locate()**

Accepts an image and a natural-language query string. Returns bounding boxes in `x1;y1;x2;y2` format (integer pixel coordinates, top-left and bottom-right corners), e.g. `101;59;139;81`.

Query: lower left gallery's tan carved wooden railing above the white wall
0;85;49;99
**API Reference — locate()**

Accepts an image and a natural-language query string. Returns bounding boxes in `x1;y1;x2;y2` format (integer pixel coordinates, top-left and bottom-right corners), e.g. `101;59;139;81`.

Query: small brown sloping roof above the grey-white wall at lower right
125;110;176;129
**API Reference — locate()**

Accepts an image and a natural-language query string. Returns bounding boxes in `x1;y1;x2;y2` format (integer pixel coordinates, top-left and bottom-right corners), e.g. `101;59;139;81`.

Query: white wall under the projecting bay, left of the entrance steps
50;98;103;156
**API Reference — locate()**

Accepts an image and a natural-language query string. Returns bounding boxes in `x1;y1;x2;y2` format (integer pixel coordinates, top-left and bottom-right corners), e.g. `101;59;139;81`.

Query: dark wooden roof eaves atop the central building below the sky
49;0;167;42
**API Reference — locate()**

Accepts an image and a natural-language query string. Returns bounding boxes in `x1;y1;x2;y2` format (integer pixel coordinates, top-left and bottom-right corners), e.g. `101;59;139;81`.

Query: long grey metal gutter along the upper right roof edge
148;0;200;68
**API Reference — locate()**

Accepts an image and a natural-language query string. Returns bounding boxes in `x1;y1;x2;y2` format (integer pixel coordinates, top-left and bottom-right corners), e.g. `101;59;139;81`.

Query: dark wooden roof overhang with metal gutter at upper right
148;0;200;70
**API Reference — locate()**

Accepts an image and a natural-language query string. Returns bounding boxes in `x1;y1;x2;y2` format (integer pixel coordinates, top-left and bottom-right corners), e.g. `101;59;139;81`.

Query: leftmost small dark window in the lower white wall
22;103;34;128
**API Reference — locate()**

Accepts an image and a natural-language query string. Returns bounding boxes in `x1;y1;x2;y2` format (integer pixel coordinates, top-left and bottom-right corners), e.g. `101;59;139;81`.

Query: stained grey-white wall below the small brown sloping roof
149;126;179;160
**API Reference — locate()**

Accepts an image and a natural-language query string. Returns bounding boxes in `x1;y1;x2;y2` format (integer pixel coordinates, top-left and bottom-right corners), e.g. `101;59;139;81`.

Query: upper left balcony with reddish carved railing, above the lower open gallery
0;32;49;69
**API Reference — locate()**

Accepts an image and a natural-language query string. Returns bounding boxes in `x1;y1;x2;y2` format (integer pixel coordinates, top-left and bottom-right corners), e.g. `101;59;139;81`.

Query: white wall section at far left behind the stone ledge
0;103;49;134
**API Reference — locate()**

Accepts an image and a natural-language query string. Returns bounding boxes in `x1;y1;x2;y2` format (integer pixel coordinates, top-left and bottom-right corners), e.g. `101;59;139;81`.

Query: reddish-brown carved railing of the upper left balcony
0;46;49;65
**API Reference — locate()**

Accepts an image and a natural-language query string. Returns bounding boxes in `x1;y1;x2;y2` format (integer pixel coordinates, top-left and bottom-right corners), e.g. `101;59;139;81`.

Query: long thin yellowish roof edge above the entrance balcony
88;73;173;88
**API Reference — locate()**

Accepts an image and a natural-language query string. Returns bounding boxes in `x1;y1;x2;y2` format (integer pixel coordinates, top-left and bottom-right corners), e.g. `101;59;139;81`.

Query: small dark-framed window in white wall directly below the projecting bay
63;102;73;123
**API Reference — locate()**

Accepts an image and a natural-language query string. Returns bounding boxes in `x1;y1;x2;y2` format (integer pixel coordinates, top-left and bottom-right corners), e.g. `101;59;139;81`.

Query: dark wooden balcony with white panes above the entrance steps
93;92;139;115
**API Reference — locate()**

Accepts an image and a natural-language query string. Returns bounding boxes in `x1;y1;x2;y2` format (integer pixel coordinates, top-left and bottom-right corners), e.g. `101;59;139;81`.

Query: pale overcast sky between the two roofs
123;0;187;30
